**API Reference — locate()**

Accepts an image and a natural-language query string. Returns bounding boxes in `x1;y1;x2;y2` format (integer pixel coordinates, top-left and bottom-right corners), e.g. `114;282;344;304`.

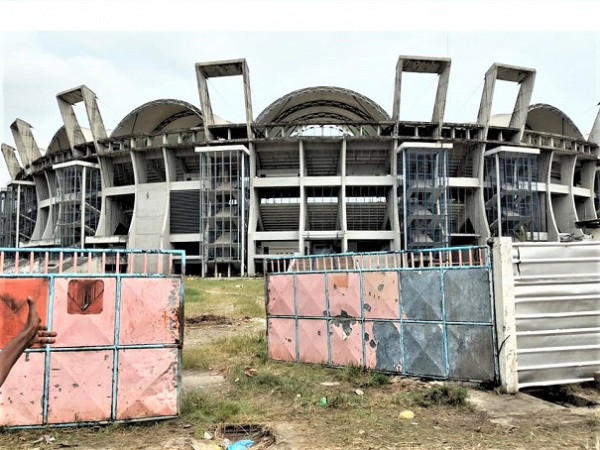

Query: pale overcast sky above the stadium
0;2;600;186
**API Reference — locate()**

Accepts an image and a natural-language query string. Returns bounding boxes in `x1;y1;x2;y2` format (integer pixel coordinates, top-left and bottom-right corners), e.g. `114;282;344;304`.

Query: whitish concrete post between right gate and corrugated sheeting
492;237;519;394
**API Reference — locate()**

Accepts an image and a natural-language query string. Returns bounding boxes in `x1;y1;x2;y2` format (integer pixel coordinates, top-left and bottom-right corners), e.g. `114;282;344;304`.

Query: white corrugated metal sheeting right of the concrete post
513;241;600;388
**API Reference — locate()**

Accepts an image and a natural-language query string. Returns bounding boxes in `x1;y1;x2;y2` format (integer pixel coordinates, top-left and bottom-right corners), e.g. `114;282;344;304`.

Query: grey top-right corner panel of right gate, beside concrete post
444;269;492;322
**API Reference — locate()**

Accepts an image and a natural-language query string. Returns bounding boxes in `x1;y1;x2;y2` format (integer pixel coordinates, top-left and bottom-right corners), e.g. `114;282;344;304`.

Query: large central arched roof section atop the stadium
256;86;390;123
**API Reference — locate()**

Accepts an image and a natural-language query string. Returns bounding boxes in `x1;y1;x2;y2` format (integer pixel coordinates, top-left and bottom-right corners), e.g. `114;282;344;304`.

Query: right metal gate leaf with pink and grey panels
266;247;497;381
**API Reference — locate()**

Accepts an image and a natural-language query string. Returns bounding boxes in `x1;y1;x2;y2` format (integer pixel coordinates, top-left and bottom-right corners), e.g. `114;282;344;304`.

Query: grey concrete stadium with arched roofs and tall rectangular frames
0;56;600;276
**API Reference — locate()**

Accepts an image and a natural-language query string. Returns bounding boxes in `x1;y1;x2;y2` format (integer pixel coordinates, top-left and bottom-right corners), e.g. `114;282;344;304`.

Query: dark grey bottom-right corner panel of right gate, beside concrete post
447;326;495;380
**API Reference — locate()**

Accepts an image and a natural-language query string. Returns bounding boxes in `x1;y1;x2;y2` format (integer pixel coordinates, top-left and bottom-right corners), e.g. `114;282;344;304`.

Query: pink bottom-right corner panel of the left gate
117;348;178;419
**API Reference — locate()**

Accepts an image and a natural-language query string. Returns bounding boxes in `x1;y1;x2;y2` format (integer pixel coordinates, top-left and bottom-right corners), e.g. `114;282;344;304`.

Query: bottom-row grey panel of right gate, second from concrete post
403;323;446;377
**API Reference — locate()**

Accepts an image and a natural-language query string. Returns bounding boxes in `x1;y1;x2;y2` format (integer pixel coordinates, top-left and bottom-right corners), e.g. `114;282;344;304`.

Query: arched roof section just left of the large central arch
110;99;203;138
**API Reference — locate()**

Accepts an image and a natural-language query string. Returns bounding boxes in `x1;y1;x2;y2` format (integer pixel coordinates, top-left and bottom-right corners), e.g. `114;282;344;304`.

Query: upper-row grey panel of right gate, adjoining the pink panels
400;270;442;320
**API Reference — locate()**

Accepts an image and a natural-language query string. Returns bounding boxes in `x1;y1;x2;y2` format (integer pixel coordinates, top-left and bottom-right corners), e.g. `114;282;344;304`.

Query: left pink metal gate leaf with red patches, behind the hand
0;249;185;427
